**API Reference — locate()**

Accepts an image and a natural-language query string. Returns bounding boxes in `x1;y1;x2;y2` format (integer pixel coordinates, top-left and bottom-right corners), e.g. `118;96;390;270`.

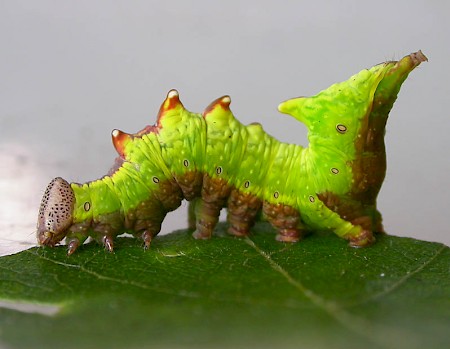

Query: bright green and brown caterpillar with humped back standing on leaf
37;51;427;255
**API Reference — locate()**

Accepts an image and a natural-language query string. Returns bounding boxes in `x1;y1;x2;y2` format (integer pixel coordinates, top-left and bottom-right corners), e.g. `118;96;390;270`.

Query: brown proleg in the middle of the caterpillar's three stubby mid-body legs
227;189;262;236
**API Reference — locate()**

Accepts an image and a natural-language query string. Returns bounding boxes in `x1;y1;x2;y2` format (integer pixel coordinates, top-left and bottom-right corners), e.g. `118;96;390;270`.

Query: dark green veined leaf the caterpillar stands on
0;224;450;349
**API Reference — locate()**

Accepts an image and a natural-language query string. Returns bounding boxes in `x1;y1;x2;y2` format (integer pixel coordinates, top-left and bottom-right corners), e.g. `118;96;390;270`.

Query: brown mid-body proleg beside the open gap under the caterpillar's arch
192;174;231;239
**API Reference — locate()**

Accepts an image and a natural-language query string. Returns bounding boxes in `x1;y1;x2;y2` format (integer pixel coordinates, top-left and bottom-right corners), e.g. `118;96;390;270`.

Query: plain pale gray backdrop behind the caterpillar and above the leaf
0;0;450;253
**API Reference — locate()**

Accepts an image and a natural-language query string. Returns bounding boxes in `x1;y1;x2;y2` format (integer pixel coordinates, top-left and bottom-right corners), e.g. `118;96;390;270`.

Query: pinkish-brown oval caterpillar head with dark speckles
36;177;75;246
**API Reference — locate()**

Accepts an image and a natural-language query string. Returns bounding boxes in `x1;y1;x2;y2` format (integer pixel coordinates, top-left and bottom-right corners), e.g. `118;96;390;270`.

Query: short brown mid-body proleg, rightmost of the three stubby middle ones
263;201;302;242
